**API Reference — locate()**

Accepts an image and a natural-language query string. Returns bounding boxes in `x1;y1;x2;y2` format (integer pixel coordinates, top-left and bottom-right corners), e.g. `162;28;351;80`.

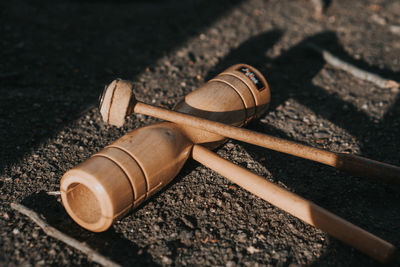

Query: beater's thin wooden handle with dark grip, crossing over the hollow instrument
133;102;400;184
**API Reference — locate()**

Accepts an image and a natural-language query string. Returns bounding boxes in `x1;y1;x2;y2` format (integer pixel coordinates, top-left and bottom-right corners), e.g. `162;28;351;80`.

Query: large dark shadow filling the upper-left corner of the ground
0;0;241;168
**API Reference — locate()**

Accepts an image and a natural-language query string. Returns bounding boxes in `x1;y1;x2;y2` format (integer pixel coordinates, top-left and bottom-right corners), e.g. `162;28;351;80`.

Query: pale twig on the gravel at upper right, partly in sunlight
307;43;400;89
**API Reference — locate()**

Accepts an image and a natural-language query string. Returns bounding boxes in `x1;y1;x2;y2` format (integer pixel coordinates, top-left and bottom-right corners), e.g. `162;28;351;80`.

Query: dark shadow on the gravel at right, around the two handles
208;30;400;266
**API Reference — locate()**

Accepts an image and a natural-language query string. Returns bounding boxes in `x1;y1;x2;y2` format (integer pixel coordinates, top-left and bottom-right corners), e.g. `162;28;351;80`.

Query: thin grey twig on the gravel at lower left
10;203;121;267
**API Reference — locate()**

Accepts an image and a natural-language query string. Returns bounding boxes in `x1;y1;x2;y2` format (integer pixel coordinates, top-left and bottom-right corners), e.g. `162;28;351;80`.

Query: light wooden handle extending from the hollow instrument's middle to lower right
192;145;397;263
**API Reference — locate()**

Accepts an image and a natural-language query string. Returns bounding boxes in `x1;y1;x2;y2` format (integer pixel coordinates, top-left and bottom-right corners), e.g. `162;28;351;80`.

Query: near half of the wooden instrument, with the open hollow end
61;122;192;232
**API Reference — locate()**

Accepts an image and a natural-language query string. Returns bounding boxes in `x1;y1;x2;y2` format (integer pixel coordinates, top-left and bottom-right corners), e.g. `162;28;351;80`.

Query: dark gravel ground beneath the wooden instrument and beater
0;0;400;266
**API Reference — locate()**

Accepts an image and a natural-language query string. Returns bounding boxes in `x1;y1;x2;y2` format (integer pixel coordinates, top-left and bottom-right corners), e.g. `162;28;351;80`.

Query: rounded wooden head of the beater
99;79;136;127
